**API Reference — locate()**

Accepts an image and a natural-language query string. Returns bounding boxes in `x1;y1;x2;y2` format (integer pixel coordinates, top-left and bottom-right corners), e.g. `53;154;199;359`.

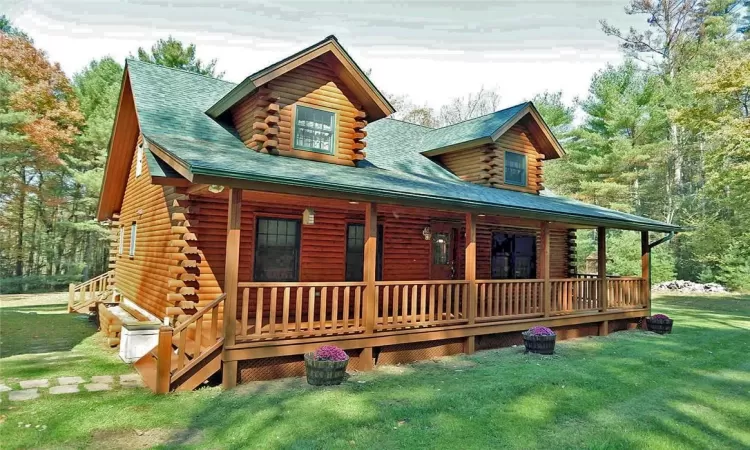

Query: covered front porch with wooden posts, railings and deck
212;189;650;387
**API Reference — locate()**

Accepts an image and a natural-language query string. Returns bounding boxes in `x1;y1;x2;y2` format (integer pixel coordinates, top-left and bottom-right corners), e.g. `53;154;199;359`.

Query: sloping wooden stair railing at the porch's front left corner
156;294;226;394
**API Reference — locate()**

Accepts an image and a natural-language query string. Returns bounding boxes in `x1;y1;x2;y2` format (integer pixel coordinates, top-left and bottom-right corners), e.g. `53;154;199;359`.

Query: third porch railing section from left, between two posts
476;279;544;321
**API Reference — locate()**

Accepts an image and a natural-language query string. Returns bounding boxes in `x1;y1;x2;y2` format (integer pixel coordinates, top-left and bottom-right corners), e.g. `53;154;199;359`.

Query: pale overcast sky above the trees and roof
0;0;643;107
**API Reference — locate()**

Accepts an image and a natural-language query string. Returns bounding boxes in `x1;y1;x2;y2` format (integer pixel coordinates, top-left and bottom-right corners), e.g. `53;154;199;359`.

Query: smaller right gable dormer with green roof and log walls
422;102;564;194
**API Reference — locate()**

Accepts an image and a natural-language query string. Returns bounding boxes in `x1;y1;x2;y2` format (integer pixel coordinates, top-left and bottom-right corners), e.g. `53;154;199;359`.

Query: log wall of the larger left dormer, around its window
231;57;367;165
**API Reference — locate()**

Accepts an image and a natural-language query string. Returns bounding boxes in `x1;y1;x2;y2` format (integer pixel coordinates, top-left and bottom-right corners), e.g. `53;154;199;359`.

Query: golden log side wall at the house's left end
113;138;173;318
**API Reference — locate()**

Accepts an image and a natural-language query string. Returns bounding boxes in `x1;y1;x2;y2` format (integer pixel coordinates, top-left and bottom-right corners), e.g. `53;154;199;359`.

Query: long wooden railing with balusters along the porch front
236;277;648;340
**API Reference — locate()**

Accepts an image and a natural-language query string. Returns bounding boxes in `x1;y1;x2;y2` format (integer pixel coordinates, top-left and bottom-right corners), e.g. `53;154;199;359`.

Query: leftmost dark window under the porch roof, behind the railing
253;217;300;281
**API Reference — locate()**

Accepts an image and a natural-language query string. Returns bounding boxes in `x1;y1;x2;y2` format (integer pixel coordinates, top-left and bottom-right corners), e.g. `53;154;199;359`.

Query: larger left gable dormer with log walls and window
207;36;394;165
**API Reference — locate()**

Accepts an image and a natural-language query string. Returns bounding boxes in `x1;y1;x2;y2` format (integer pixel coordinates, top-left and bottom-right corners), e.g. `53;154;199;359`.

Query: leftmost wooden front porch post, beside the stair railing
221;188;242;389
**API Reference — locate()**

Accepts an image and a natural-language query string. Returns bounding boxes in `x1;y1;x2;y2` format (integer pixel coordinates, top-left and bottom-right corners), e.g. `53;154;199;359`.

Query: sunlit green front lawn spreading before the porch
0;296;750;449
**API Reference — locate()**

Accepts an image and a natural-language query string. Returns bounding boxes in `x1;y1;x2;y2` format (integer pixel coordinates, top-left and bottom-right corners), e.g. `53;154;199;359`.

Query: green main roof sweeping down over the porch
127;60;679;231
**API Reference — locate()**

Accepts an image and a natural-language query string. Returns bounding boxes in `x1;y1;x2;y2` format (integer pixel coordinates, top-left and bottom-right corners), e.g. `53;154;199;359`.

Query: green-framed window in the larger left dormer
294;105;336;155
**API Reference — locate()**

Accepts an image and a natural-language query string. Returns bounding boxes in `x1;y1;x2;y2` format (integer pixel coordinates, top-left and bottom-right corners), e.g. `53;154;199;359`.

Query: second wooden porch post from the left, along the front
360;203;378;370
